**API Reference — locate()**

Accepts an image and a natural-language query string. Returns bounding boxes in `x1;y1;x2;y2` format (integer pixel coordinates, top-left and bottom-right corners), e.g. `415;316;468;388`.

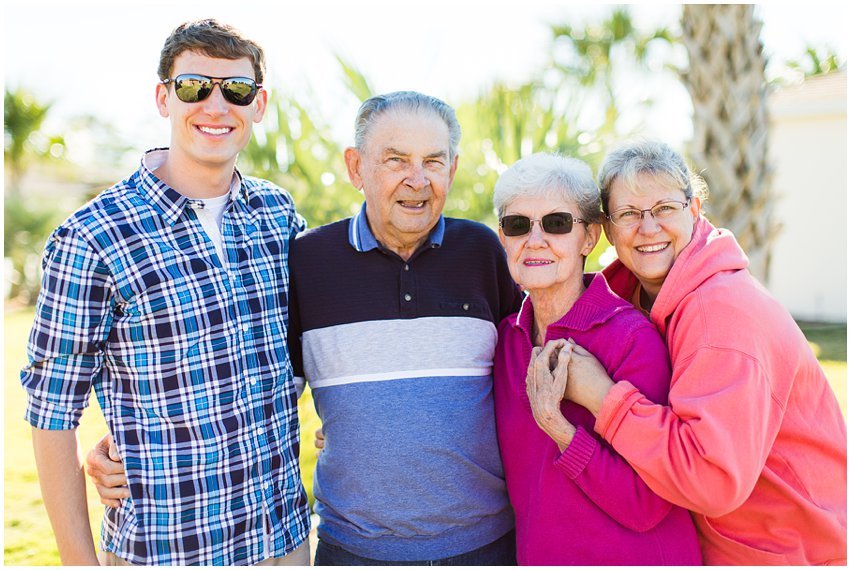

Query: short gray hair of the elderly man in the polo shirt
355;91;461;160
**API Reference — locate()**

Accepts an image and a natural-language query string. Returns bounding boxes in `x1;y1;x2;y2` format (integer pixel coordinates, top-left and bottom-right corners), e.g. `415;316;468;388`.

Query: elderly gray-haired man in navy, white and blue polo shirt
91;92;520;565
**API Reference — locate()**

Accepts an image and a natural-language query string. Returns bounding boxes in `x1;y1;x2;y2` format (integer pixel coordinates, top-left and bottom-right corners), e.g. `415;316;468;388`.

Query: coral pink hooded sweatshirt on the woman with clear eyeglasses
594;217;847;565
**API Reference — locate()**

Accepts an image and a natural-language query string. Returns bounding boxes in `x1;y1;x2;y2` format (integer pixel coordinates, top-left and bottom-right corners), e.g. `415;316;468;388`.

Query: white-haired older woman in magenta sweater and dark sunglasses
494;154;701;565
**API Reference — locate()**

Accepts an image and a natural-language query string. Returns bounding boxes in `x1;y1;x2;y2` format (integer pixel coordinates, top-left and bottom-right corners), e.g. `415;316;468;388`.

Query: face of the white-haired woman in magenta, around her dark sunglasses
499;195;600;305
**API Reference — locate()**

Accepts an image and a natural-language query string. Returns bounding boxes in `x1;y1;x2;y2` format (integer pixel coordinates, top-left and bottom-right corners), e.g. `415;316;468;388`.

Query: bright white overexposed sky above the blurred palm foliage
3;0;849;163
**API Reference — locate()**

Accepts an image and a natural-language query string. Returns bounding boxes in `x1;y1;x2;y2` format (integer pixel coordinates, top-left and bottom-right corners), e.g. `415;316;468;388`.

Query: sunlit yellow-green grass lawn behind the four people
3;309;847;566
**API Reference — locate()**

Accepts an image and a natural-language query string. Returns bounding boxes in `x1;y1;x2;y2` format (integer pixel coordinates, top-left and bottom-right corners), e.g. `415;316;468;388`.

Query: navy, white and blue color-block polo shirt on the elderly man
289;205;520;561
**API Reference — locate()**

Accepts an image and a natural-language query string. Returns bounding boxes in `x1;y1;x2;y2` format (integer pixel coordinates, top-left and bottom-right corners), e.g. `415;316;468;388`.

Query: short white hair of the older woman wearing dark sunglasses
493;152;601;222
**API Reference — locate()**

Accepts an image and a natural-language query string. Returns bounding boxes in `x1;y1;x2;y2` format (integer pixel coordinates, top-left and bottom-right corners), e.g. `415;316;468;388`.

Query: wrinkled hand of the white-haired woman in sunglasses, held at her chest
526;340;576;451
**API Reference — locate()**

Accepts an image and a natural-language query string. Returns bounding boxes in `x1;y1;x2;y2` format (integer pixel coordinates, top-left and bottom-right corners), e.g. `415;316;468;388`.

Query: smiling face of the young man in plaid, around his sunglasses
157;51;267;178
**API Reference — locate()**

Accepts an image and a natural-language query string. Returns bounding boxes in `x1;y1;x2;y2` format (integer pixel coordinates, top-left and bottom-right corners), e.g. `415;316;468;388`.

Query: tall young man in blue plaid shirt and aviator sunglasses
21;20;309;565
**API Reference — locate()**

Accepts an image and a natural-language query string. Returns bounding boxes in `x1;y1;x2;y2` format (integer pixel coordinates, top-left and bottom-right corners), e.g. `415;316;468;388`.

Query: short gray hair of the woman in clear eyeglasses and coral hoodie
597;140;707;214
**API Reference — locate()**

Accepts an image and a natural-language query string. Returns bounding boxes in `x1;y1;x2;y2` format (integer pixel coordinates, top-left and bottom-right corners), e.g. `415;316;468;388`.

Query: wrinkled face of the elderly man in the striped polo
345;110;458;259
